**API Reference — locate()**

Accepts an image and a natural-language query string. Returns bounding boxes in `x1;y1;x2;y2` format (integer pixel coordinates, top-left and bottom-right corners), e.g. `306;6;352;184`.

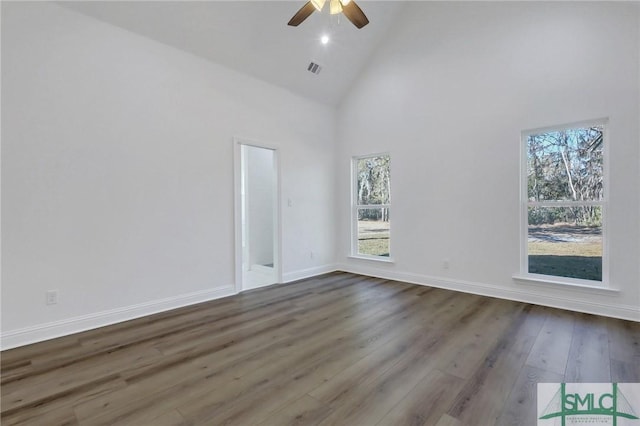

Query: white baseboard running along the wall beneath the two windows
337;264;640;322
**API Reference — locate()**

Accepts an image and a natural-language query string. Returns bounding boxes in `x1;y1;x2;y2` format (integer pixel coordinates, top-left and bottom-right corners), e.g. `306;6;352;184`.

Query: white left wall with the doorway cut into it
2;2;335;348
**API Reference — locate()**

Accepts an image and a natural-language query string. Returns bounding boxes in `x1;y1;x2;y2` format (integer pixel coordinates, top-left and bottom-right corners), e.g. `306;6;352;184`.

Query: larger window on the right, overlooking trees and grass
522;120;607;285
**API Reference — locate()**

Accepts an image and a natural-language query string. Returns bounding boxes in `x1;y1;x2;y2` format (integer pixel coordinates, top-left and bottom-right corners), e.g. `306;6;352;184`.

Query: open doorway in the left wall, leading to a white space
234;139;280;291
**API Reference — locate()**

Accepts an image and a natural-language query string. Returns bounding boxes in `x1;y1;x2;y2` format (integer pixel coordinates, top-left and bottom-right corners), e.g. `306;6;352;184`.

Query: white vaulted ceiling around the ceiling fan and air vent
59;0;403;105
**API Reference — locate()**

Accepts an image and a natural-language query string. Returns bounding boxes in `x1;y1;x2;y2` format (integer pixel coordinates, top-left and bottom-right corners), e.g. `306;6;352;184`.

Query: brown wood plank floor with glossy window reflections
0;273;640;426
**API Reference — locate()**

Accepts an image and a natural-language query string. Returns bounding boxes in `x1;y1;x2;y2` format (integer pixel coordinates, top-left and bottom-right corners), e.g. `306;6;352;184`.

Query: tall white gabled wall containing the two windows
337;2;640;320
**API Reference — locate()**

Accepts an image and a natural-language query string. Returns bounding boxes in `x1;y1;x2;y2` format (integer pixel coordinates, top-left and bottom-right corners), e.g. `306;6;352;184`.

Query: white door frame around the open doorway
233;137;282;293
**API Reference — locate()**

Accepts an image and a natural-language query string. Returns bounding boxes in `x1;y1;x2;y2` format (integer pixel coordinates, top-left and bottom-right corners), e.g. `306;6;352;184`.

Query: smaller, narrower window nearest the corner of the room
351;154;391;259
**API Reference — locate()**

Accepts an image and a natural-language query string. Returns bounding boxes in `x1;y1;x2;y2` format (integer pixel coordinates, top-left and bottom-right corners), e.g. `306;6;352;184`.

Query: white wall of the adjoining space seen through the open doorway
242;145;275;267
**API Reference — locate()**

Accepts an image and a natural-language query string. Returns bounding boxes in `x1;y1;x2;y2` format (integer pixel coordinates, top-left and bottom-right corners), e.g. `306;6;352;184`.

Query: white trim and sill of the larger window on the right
513;118;616;291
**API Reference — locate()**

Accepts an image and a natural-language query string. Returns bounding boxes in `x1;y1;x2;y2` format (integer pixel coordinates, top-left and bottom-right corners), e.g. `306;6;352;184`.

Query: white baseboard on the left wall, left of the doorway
0;285;236;350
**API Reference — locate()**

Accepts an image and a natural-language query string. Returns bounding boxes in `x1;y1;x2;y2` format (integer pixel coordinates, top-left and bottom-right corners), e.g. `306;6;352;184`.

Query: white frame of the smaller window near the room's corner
349;152;394;263
